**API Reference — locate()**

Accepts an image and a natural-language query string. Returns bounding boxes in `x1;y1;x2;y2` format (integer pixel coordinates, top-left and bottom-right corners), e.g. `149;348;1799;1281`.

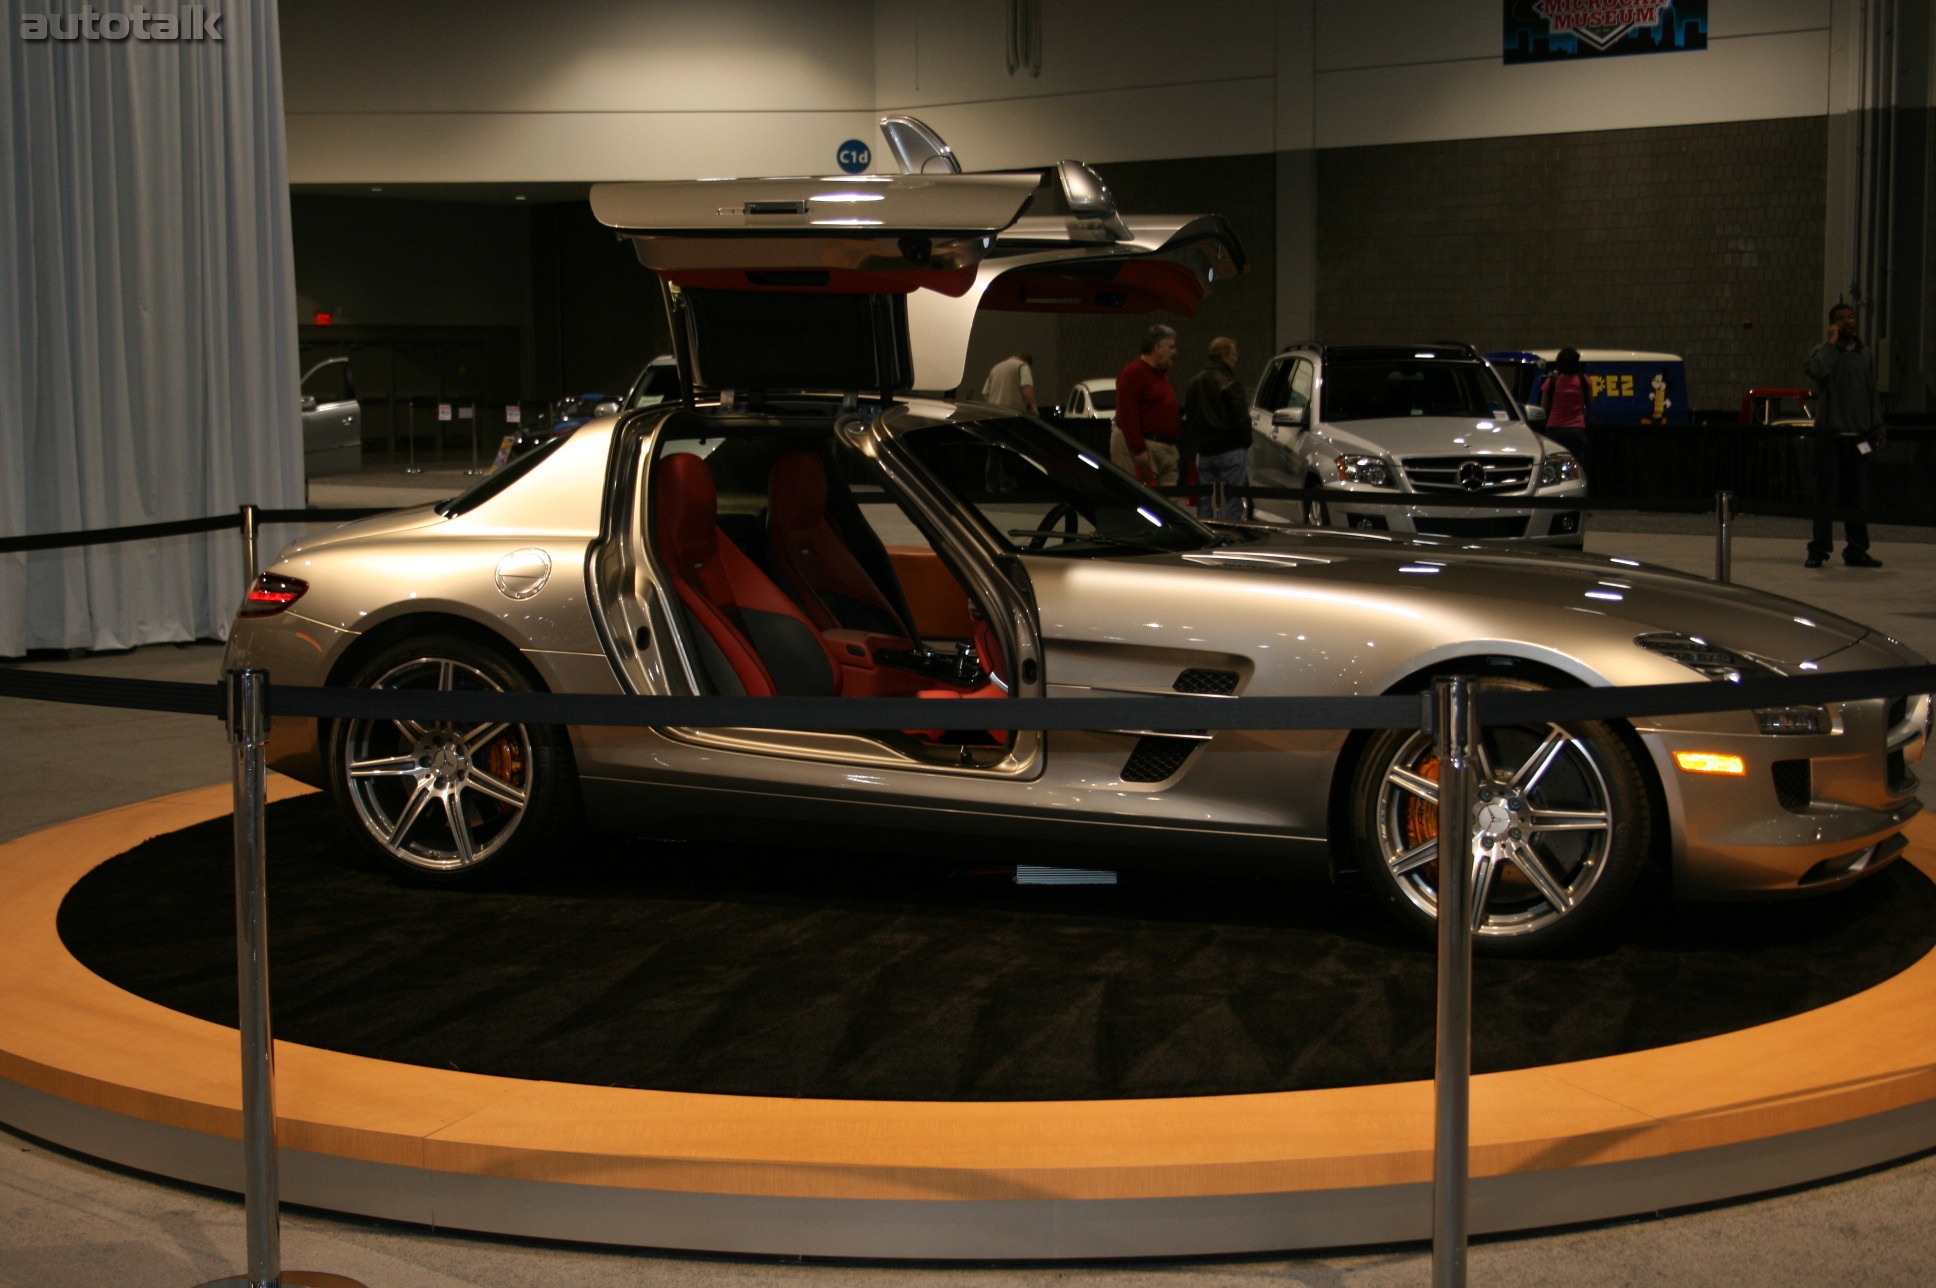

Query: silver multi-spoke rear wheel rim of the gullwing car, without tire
339;657;532;874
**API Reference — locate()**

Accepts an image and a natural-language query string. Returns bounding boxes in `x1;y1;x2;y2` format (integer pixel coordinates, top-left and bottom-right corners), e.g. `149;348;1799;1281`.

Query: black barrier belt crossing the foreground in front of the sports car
0;666;1936;732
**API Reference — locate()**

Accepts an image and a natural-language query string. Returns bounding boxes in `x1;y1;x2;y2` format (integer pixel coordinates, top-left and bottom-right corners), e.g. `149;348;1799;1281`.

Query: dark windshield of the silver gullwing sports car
896;416;1216;558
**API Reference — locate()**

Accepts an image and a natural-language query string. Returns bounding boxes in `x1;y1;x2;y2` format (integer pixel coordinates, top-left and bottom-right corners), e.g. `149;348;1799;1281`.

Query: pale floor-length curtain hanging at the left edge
0;0;302;657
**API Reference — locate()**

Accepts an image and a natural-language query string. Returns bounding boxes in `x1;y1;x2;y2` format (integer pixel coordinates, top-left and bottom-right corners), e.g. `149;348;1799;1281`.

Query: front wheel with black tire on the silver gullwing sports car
1351;680;1651;957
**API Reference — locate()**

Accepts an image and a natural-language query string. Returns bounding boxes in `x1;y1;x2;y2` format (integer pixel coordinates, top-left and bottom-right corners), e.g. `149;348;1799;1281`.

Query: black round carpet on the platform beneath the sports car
60;796;1936;1100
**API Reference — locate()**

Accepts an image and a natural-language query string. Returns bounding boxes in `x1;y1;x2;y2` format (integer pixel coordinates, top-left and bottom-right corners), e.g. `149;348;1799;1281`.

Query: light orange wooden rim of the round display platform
0;782;1936;1208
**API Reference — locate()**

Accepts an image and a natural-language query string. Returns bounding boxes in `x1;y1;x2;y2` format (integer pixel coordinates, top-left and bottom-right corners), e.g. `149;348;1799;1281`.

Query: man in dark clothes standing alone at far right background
1802;304;1882;567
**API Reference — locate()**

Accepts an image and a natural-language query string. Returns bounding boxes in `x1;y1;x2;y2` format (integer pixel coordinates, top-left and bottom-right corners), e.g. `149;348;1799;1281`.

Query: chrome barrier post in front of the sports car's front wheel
1433;676;1479;1288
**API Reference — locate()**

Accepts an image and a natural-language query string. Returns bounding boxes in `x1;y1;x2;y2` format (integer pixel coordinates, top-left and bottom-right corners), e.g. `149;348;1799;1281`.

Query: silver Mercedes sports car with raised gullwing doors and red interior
228;122;1928;951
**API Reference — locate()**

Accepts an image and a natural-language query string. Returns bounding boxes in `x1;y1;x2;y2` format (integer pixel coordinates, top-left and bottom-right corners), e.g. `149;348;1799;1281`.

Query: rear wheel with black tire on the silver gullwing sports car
329;635;577;885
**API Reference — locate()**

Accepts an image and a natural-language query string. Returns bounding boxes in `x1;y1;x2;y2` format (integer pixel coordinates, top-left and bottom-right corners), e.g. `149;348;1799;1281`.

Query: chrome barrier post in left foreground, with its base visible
201;668;362;1288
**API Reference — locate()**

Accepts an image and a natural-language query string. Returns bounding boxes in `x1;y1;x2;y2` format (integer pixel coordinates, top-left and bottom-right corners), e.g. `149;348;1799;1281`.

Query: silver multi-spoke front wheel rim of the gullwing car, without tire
1373;712;1644;943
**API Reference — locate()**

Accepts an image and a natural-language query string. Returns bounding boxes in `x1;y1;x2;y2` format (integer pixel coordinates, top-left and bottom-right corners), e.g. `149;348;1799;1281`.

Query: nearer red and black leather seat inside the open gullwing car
652;453;840;697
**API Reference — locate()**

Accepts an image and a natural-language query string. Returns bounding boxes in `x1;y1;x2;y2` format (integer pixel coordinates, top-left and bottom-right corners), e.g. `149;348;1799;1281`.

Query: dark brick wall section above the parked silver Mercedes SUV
1308;116;1828;409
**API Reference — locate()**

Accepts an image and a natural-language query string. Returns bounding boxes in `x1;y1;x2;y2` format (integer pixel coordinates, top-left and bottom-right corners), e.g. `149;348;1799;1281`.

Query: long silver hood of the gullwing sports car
1181;533;1922;684
